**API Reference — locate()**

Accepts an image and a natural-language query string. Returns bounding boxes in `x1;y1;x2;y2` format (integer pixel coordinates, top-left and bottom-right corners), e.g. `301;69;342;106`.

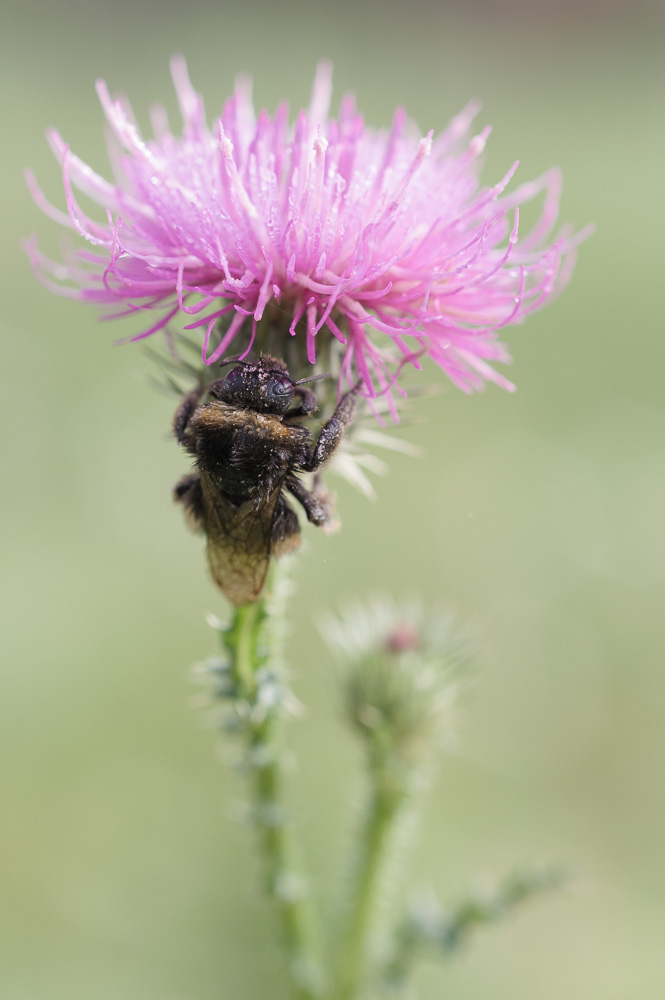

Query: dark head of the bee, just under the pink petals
208;355;295;416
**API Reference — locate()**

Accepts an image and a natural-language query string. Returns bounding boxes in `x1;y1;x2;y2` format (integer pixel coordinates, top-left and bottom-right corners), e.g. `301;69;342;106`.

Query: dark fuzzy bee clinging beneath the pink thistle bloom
173;354;358;606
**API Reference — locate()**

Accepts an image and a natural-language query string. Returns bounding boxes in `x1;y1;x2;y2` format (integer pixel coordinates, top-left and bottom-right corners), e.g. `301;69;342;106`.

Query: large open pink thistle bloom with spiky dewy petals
27;58;584;408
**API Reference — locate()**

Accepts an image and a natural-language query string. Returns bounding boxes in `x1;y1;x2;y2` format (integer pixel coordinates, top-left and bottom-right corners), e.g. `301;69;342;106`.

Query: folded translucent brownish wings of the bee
204;474;280;605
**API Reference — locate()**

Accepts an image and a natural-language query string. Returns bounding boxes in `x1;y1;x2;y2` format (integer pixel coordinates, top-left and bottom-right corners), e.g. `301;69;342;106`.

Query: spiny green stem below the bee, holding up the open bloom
224;584;322;1000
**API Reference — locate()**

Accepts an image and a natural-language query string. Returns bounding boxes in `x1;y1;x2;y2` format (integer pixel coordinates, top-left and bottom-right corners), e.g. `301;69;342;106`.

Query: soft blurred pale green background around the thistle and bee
0;0;665;1000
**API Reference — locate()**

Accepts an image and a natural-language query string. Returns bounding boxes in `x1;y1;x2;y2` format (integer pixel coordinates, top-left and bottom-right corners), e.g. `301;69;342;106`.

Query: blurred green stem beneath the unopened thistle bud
335;765;404;1000
